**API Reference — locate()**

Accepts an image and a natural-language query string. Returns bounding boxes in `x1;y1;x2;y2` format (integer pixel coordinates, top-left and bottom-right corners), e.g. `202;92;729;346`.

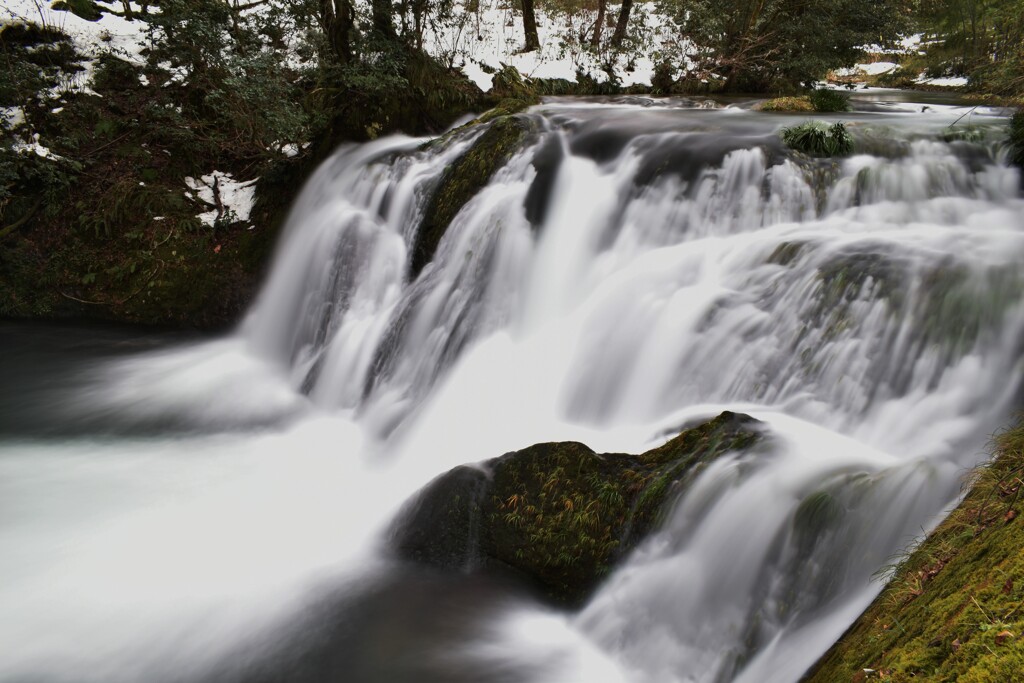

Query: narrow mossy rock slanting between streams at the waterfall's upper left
411;116;535;278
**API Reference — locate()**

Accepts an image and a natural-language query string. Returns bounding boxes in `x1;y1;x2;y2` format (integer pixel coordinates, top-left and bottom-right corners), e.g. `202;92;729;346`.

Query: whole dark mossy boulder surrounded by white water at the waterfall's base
392;413;762;606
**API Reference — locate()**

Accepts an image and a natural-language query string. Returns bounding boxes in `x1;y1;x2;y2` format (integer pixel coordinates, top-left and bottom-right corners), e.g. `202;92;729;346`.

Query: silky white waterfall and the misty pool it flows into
0;100;1024;683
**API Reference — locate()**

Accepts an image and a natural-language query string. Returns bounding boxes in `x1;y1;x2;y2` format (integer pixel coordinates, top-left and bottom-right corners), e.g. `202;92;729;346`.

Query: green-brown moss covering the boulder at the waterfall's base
485;413;760;603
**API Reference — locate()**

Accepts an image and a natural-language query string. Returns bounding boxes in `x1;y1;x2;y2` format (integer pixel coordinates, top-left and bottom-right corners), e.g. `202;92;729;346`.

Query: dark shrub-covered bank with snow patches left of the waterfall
0;0;485;328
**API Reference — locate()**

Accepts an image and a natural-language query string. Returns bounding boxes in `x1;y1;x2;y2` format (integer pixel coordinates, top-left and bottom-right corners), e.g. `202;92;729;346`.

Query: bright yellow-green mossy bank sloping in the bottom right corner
804;423;1024;683
